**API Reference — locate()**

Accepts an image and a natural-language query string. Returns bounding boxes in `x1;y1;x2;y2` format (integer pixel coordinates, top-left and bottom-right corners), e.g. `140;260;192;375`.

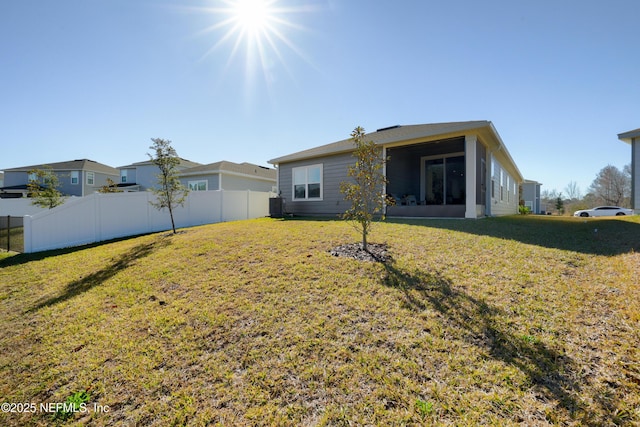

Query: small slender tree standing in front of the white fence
147;138;189;234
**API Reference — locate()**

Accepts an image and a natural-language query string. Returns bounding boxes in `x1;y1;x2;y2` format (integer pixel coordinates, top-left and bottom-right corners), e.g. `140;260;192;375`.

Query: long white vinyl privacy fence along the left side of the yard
24;190;272;253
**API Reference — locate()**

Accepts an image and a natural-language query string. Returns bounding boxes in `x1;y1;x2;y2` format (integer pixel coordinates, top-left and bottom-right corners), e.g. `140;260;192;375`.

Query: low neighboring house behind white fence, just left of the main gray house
179;160;276;191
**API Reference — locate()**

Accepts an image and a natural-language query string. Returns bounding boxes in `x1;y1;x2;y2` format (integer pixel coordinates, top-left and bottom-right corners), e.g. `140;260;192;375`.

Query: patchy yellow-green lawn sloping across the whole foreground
0;216;640;426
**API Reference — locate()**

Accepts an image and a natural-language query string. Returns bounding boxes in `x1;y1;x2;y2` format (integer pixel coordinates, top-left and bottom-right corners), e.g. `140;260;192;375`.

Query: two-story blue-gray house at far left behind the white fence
0;159;119;198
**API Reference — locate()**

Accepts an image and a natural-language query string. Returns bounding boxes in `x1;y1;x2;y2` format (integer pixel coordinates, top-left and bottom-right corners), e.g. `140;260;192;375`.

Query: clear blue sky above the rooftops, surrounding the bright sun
0;0;640;192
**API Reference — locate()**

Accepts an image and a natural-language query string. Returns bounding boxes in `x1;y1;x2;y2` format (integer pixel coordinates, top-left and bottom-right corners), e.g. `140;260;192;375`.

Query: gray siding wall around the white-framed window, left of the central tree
278;153;355;215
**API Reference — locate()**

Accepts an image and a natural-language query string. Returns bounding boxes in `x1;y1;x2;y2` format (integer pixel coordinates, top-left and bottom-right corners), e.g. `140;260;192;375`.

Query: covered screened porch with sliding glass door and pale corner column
384;135;487;218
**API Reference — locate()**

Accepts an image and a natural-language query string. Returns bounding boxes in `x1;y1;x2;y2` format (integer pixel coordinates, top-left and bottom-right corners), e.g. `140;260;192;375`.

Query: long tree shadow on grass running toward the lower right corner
383;262;610;425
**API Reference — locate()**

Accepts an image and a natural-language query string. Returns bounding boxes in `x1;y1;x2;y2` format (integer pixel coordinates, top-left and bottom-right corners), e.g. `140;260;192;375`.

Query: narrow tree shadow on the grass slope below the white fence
27;239;168;313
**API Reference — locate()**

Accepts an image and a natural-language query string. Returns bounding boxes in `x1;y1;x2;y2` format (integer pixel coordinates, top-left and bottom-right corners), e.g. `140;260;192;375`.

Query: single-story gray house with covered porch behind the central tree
269;121;523;218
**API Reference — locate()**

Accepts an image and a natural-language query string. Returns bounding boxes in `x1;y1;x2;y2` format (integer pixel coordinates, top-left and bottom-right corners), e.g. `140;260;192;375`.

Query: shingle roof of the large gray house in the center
269;120;491;164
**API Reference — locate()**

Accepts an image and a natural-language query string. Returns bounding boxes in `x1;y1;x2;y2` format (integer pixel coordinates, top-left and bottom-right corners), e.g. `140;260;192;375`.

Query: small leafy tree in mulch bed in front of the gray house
340;126;387;251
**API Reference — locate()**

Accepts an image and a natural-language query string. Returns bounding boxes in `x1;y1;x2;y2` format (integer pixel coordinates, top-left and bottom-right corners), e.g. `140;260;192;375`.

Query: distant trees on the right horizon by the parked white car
540;164;631;215
